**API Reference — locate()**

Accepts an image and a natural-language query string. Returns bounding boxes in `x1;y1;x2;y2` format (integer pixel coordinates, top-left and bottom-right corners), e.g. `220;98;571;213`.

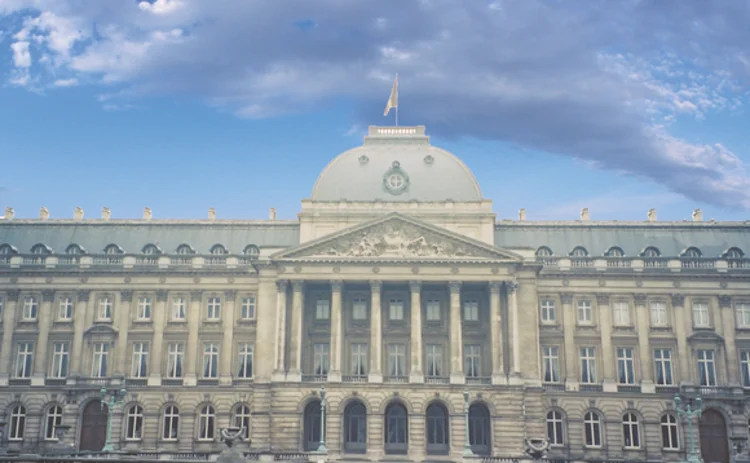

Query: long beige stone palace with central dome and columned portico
0;126;750;461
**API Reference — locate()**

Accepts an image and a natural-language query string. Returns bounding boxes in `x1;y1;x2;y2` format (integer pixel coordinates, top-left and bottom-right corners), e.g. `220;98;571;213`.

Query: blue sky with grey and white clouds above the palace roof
0;0;750;220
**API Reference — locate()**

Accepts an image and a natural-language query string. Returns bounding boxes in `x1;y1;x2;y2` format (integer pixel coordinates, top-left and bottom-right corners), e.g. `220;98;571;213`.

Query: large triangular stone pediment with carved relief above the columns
271;213;522;261
